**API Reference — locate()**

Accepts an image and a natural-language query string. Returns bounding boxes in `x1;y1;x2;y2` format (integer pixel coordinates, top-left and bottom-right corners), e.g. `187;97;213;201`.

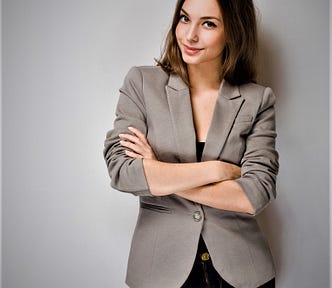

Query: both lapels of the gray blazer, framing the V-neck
166;74;244;162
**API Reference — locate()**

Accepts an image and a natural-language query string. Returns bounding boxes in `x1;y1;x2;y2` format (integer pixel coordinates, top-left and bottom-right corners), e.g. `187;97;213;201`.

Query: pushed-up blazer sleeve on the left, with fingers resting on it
103;67;152;196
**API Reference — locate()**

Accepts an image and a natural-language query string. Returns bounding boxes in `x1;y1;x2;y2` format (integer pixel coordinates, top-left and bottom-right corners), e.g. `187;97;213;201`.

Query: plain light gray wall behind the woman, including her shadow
0;0;330;288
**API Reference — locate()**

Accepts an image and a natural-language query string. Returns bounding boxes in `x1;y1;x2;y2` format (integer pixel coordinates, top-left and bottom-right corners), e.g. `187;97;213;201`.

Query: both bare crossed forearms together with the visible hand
120;127;254;214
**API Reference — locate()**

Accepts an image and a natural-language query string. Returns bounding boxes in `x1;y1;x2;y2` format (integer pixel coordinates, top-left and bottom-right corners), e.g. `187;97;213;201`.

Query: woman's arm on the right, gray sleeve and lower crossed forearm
177;88;279;215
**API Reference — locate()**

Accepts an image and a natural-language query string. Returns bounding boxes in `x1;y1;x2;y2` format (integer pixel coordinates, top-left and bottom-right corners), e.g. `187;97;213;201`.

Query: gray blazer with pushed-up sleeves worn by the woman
104;67;278;288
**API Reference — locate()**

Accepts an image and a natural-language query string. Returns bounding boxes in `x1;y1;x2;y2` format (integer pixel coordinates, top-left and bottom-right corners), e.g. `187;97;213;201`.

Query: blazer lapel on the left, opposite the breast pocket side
166;74;196;162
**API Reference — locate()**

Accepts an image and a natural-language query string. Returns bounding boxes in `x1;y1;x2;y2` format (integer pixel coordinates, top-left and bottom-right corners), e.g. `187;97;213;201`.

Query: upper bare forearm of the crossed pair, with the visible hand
119;127;240;196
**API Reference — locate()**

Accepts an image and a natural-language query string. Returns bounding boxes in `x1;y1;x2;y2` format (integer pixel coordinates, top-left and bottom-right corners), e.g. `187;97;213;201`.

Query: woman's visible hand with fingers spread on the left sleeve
119;127;157;160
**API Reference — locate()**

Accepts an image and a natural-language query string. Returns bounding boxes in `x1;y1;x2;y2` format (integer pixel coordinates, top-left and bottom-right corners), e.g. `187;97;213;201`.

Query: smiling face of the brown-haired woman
176;0;225;65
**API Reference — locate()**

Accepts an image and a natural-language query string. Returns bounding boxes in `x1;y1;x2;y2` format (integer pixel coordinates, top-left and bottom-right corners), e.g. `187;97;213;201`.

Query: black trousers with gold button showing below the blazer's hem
181;237;275;288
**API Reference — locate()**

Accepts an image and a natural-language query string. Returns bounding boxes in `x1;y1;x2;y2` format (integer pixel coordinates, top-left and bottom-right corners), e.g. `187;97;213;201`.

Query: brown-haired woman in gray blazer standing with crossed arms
104;0;278;288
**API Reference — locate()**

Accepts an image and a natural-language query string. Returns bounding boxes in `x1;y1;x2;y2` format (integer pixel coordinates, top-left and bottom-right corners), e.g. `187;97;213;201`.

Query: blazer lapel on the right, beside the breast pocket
202;80;244;161
